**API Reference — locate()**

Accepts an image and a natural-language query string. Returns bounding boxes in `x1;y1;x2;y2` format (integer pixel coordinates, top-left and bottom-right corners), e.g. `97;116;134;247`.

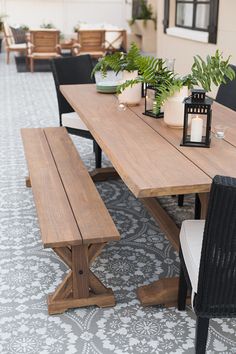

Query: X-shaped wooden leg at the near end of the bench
48;243;115;315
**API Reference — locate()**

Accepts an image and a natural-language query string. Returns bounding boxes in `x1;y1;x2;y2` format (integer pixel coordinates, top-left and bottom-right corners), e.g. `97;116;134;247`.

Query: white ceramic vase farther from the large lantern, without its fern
118;70;141;106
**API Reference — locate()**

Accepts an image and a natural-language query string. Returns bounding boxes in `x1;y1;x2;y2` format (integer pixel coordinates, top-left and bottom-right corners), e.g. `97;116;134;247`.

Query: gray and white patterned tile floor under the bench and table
0;54;236;354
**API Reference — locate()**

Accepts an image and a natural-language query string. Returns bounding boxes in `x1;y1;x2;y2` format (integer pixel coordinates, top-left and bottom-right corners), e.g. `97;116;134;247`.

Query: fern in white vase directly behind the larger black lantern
118;50;235;128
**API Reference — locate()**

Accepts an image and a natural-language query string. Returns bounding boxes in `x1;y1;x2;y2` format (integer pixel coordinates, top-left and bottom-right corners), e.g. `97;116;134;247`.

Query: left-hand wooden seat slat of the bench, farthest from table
21;128;82;247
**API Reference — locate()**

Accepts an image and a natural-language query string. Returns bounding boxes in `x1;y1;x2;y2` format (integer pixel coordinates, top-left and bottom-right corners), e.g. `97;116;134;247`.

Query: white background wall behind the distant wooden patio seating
0;0;132;34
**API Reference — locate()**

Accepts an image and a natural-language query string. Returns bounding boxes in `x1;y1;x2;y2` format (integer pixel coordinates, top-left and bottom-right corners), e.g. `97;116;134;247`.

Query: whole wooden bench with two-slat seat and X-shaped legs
21;127;120;314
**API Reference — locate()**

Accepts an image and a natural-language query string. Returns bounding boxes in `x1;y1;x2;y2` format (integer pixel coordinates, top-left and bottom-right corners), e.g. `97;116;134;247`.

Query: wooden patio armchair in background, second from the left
27;29;61;72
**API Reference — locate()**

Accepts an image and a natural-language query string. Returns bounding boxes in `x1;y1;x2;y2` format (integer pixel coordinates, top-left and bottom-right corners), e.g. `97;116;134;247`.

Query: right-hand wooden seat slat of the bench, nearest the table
44;127;120;244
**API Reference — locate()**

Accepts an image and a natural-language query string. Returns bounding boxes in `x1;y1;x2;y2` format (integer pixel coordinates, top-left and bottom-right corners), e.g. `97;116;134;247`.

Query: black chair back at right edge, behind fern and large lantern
216;65;236;111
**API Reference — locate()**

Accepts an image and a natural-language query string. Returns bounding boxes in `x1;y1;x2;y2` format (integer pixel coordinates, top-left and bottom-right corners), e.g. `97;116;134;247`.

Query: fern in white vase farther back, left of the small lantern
93;43;141;105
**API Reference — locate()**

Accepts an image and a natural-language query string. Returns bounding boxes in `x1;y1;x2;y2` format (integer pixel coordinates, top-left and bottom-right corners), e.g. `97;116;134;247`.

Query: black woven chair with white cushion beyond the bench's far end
51;55;102;168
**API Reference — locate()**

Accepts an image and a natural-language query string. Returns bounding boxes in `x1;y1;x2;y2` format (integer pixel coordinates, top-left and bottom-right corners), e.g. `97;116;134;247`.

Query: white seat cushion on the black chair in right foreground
179;220;205;293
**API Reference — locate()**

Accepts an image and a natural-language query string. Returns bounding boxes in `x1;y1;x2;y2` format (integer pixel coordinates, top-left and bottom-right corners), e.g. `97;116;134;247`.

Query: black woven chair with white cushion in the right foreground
178;176;236;354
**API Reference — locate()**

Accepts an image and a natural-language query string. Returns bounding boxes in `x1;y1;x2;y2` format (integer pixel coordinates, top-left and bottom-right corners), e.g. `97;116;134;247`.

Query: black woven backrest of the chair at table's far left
51;55;95;115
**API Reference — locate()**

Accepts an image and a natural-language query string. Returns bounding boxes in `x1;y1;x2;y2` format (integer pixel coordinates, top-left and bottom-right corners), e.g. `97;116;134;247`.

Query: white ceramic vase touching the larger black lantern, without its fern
164;86;188;128
